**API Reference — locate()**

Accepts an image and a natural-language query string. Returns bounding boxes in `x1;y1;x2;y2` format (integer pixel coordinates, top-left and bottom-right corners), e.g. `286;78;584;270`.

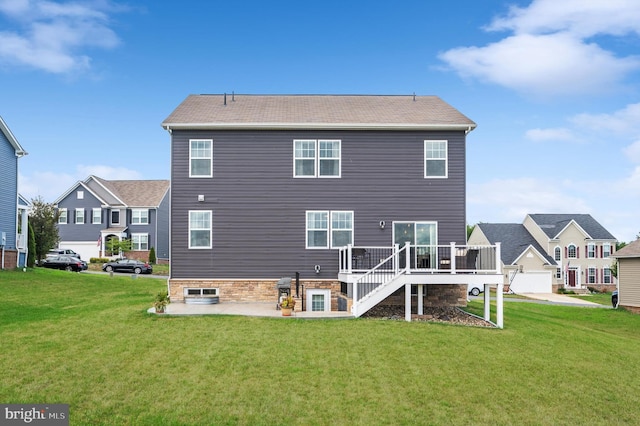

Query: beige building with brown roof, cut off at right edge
612;239;640;314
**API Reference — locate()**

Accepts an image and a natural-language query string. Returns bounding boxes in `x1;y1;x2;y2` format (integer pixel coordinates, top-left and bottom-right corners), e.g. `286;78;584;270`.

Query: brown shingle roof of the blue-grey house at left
93;176;169;207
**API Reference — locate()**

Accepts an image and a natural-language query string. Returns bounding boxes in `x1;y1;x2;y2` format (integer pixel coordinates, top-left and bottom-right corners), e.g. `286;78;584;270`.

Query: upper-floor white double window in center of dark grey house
293;139;342;178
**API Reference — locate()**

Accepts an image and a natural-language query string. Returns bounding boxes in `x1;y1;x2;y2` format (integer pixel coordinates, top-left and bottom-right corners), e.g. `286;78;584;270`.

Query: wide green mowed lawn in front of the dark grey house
0;269;640;425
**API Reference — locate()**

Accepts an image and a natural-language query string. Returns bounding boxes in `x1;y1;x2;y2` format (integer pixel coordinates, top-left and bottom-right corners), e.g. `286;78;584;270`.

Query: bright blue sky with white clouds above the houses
0;0;640;242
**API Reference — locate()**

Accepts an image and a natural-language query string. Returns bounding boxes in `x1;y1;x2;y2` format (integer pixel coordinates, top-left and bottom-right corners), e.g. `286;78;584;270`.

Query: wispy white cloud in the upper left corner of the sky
0;0;120;73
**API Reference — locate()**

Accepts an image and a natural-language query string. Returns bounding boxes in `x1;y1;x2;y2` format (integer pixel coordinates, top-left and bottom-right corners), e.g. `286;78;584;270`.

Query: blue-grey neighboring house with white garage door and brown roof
54;176;169;261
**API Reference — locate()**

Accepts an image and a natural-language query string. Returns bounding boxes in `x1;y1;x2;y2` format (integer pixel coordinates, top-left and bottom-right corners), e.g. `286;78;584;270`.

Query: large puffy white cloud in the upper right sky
440;0;640;96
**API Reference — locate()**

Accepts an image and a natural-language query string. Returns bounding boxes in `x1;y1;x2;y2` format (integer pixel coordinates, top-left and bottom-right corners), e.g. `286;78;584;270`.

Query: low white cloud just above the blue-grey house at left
18;165;142;202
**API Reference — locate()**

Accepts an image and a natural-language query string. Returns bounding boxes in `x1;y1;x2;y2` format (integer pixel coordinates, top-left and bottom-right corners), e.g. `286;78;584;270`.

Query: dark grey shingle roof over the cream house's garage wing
477;223;556;265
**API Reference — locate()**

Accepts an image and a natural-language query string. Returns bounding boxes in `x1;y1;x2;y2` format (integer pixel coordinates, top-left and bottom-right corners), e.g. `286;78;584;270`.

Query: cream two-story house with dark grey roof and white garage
469;214;616;293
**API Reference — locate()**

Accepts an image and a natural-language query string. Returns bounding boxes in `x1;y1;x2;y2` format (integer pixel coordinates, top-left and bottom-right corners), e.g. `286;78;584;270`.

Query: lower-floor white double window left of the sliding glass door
306;211;353;249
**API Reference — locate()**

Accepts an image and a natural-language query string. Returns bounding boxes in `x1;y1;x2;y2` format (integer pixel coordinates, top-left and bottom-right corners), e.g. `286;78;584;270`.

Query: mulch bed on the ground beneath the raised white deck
362;305;495;327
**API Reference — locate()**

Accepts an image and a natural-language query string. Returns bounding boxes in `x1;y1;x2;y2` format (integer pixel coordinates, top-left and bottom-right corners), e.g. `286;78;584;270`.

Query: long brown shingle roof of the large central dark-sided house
162;95;476;130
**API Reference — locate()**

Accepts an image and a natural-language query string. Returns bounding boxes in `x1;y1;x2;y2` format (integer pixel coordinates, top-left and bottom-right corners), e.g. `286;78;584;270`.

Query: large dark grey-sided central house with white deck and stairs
162;95;502;324
